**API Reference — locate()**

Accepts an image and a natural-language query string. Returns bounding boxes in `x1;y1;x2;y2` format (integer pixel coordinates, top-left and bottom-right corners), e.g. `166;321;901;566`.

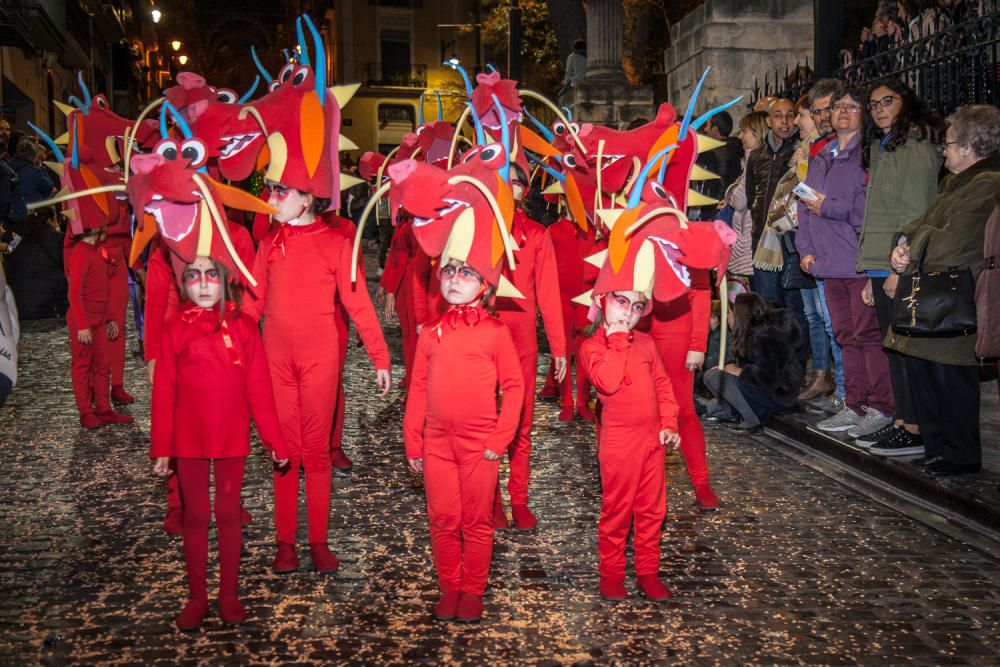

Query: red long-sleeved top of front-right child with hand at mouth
580;327;678;431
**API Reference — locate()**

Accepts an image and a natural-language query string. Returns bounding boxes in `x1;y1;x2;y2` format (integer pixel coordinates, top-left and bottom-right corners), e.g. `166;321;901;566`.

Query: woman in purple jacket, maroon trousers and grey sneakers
795;86;893;437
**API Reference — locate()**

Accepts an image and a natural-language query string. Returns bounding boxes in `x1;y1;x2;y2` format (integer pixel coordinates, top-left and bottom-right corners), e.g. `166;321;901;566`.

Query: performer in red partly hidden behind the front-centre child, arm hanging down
494;206;566;530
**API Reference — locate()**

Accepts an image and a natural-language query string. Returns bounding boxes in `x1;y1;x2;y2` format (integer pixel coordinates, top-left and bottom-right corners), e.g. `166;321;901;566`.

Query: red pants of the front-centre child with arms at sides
424;433;500;596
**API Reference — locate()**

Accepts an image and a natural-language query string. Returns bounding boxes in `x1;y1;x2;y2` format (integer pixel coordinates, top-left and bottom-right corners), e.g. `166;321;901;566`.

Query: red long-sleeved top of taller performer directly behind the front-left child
244;221;390;369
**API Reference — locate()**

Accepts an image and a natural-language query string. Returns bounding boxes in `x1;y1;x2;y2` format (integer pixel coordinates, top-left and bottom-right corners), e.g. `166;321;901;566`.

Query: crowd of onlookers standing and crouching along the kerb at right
703;75;1000;476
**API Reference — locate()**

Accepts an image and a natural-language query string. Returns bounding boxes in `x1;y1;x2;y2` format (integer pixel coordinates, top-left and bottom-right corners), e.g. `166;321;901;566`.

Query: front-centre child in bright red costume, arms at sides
403;260;525;623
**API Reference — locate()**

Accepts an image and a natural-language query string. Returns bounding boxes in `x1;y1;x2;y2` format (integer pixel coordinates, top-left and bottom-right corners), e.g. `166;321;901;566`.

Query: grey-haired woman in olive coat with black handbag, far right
885;105;1000;477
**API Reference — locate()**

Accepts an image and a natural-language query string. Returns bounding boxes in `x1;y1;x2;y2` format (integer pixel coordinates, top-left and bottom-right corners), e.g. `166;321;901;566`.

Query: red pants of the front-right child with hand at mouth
597;426;667;579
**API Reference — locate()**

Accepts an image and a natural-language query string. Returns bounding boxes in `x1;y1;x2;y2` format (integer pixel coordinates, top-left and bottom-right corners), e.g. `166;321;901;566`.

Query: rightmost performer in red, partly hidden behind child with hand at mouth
643;269;719;510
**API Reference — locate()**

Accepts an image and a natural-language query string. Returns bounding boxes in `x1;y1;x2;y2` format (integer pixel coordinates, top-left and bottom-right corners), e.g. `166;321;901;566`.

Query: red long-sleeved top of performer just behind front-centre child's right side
496;210;576;357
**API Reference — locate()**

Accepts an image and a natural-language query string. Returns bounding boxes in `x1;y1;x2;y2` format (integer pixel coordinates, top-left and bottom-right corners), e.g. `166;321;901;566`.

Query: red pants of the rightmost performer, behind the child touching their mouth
653;331;708;484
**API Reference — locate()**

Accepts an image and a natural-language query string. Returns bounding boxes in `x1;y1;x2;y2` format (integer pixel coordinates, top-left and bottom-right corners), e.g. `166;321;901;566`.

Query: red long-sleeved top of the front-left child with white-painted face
150;304;288;459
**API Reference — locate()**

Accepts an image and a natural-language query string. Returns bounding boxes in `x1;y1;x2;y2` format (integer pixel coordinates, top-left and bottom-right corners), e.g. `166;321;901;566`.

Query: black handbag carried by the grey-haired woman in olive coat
892;241;976;338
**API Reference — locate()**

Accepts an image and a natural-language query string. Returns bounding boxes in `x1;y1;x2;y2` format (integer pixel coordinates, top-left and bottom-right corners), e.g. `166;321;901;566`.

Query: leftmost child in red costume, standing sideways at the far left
66;227;132;428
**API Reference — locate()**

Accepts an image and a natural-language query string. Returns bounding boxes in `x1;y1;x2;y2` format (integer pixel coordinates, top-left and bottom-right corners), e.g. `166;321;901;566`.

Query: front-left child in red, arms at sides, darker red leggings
150;256;288;630
